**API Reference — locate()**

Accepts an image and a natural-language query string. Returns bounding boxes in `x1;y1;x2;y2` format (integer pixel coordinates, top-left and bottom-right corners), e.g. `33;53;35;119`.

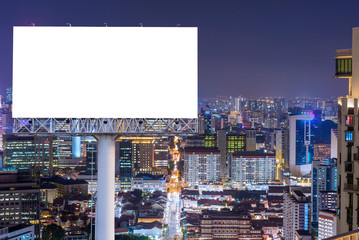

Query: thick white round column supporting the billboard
95;134;116;240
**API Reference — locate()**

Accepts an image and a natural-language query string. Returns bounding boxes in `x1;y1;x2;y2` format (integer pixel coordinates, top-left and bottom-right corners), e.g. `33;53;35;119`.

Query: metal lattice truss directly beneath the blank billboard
13;118;198;136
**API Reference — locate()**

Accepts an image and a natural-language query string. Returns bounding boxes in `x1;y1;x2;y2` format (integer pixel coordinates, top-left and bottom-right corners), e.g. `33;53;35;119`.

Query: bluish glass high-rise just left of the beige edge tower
311;159;337;223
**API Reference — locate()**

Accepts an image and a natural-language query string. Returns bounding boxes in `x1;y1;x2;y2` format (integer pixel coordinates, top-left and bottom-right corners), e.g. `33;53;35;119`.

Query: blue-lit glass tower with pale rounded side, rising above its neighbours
288;109;314;177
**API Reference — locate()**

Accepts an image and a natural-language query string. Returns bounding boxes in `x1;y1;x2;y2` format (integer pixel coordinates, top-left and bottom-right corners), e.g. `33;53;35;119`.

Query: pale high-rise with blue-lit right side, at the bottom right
283;190;311;239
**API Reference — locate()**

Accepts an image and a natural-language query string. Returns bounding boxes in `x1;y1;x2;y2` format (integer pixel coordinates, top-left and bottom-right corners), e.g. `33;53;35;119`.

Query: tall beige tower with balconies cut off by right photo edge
335;28;359;234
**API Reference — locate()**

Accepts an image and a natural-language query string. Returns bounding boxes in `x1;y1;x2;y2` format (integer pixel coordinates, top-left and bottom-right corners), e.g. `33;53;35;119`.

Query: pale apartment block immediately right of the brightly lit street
182;147;221;185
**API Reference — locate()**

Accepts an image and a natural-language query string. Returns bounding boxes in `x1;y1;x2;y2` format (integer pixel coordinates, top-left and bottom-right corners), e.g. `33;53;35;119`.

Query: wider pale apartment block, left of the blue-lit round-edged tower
230;152;276;189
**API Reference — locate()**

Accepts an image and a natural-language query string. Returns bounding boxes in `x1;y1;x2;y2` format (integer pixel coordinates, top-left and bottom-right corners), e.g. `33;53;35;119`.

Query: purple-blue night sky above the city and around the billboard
0;0;359;97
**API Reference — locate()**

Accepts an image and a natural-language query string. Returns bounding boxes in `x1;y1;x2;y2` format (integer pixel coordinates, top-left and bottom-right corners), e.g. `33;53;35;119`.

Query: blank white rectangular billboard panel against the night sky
13;27;198;118
